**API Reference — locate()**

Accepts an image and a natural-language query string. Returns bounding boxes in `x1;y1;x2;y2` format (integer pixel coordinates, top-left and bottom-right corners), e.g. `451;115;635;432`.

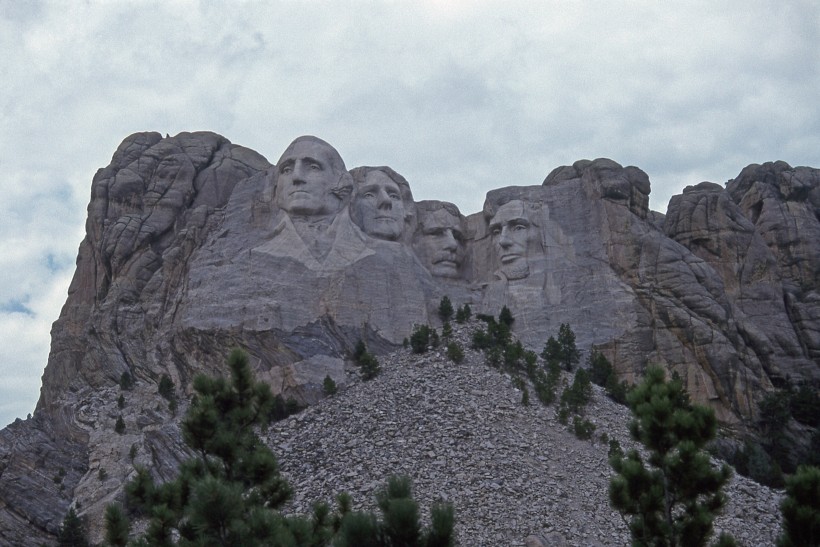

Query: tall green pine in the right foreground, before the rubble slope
609;367;732;547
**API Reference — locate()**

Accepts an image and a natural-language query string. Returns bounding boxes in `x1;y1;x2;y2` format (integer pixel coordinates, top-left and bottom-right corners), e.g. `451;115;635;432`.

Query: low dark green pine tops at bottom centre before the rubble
334;476;455;547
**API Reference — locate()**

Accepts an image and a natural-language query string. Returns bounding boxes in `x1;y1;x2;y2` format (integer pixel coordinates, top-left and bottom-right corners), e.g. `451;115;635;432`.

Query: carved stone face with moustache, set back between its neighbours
413;208;464;278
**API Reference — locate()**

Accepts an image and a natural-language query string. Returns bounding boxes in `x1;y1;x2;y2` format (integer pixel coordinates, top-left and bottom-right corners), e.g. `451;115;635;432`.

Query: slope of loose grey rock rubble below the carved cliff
267;323;781;546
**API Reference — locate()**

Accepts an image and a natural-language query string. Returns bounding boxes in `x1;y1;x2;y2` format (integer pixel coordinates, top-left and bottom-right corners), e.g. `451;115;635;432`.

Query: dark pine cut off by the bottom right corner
777;465;820;547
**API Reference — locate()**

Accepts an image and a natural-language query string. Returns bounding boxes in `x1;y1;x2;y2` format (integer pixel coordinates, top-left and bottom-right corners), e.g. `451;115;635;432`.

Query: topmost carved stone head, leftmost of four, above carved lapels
276;140;342;216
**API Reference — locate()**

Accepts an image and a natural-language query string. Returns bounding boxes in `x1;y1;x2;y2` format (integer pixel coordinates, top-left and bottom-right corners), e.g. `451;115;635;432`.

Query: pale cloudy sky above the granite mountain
0;0;820;426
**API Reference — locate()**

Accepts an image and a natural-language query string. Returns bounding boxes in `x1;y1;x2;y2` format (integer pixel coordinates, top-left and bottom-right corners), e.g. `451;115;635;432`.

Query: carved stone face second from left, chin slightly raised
353;171;406;241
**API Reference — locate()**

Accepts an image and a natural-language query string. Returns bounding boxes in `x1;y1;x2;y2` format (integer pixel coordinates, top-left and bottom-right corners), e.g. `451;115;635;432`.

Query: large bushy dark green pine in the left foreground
112;350;307;545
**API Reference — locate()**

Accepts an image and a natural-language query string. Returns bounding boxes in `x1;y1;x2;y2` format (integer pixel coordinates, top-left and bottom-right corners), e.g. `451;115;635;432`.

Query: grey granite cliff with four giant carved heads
0;133;820;544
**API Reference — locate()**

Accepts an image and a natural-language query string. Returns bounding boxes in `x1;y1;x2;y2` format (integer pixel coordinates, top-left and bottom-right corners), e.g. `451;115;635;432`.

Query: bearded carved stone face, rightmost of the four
490;200;538;279
